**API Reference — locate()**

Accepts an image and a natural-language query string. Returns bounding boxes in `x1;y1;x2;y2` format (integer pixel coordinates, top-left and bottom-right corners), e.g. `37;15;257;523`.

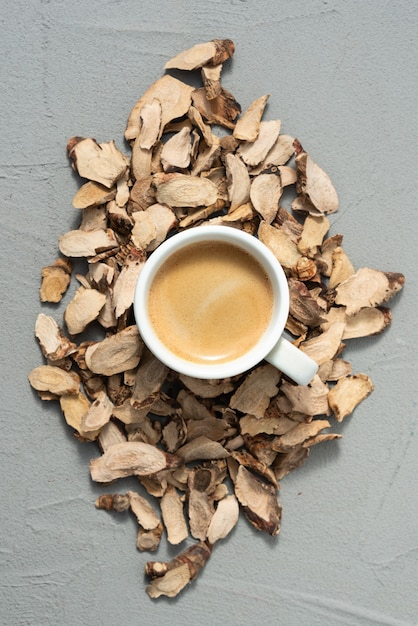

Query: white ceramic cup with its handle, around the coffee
134;226;318;385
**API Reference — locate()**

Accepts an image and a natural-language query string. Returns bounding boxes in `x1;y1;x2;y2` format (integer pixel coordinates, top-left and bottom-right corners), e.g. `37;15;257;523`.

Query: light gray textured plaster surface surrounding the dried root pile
0;0;418;626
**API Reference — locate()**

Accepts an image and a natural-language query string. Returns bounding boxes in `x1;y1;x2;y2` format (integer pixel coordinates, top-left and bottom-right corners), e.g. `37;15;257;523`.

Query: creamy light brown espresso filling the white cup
148;241;273;364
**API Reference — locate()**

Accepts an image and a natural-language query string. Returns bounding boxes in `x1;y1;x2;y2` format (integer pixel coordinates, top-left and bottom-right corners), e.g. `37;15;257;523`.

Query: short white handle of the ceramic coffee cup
265;337;318;385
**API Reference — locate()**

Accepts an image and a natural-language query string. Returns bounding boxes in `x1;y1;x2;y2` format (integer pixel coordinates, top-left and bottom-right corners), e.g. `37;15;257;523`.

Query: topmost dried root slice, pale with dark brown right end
164;39;235;71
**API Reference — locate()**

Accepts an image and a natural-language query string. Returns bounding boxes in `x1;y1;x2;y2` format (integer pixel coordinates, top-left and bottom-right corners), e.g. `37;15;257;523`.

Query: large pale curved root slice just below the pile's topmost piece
125;74;194;141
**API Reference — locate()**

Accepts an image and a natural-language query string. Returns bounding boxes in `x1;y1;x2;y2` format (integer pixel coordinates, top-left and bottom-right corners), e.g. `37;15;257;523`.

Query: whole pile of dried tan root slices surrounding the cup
28;39;405;598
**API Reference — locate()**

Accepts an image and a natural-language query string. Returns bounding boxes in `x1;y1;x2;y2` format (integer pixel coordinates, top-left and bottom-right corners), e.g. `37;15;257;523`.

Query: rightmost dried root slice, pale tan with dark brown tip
335;267;405;315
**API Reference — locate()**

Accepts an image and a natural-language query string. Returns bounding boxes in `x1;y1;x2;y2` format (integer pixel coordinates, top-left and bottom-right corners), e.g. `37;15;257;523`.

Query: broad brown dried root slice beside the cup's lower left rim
85;326;144;376
